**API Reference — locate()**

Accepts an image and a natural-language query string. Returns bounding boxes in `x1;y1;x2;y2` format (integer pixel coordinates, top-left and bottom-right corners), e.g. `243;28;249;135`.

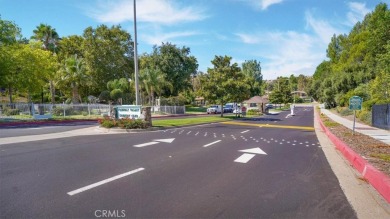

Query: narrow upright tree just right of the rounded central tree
242;60;263;96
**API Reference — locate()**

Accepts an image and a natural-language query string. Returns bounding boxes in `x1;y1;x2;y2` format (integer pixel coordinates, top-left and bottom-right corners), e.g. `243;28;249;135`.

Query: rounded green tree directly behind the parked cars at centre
201;56;250;116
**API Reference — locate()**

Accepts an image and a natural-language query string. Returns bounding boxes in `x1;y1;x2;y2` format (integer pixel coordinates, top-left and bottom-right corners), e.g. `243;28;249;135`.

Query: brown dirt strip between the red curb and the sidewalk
321;114;390;176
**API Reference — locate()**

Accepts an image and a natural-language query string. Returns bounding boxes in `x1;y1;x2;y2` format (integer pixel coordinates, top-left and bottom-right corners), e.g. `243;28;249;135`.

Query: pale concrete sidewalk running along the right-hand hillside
321;109;390;145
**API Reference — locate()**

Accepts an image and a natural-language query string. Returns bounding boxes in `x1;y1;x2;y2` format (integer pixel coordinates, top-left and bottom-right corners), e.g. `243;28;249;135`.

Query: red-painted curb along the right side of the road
316;112;390;203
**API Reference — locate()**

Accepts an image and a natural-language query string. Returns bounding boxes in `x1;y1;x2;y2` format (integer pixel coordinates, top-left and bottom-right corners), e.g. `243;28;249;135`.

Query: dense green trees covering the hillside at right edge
309;3;390;122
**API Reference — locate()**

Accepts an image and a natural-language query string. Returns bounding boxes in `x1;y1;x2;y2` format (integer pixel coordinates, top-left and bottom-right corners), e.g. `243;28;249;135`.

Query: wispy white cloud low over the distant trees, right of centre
237;31;324;79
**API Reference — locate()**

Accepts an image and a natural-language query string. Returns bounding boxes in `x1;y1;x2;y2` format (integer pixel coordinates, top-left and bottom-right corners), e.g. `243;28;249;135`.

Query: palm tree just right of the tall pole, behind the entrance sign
140;67;173;106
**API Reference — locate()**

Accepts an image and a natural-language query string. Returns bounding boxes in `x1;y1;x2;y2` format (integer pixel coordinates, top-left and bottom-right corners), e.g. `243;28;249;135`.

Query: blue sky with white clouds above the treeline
0;0;390;79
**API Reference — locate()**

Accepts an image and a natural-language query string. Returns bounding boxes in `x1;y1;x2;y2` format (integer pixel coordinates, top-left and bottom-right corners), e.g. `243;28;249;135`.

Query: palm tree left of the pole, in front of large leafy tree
61;54;88;103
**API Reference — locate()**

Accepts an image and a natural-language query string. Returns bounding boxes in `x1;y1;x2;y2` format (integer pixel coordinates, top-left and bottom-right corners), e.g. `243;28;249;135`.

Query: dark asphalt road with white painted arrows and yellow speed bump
0;108;356;218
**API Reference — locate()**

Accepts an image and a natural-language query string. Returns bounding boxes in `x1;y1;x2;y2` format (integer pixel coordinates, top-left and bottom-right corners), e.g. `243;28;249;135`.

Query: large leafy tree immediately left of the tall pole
82;25;134;93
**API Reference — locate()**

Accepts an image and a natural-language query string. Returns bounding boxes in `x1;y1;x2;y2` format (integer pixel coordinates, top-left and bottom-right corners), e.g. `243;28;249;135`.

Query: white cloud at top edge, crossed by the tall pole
87;0;207;25
